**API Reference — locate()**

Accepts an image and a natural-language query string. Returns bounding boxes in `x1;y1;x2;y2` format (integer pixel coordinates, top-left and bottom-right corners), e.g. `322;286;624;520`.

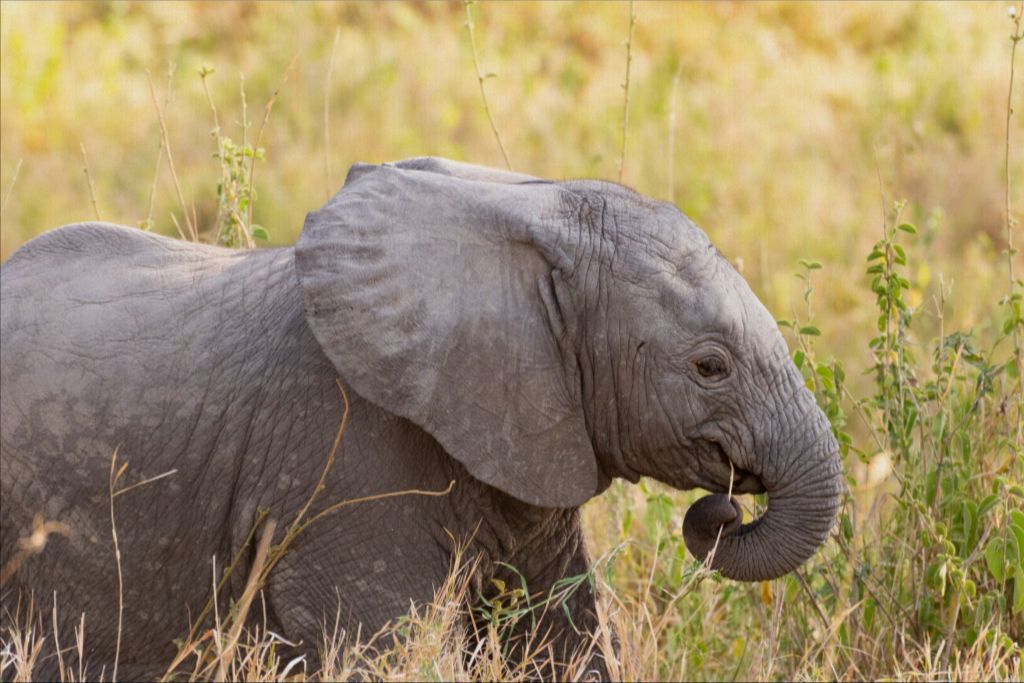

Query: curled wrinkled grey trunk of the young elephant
683;407;843;581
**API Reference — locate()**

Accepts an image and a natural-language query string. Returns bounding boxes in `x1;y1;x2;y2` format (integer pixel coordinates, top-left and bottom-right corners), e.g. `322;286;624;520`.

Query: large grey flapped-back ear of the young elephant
296;165;598;507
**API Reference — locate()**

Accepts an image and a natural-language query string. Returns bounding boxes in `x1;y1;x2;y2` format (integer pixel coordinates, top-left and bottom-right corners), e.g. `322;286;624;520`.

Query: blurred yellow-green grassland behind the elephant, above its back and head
0;2;1024;411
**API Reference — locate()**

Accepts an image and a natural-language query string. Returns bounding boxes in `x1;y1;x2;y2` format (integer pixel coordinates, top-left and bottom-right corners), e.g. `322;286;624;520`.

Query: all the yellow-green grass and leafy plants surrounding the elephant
0;2;1024;680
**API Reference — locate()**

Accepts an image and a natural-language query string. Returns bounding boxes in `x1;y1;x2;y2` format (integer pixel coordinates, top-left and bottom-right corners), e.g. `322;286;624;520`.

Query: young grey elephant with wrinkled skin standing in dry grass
0;159;841;677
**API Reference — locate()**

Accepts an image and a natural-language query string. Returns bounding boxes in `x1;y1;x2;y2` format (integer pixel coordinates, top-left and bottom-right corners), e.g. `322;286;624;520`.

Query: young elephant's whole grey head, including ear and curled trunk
296;159;841;581
